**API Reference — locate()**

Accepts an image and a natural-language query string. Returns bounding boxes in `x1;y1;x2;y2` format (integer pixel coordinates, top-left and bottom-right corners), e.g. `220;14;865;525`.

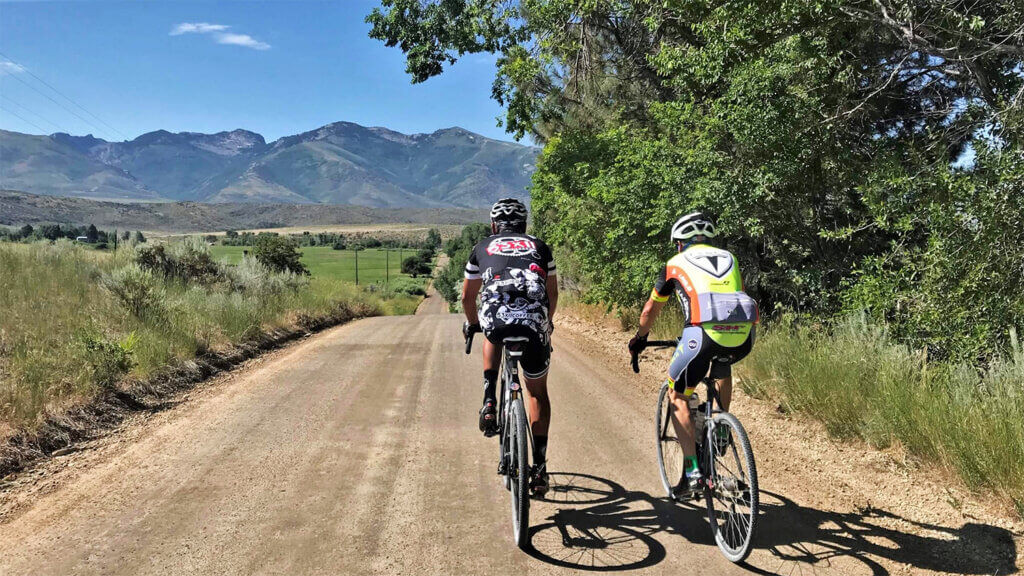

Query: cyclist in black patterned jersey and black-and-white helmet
462;198;558;495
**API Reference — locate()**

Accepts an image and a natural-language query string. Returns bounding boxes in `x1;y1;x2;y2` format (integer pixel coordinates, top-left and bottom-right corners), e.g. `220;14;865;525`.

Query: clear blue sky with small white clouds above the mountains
0;0;510;141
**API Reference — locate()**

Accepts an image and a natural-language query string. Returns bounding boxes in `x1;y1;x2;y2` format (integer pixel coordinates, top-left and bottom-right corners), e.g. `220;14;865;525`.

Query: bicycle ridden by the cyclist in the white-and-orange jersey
632;339;758;563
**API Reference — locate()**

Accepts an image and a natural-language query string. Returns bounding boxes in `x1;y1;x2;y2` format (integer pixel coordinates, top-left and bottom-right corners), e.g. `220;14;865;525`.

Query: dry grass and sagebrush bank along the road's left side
0;242;419;429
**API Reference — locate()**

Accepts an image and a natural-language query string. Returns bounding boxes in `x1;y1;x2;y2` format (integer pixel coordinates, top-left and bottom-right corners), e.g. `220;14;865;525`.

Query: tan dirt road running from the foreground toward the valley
0;296;1016;575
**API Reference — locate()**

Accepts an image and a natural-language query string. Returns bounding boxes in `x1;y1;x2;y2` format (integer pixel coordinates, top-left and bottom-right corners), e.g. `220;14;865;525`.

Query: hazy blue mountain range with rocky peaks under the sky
0;122;539;208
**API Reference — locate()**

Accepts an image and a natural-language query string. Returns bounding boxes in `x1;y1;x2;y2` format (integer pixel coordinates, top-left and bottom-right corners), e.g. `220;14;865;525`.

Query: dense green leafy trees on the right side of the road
368;0;1024;359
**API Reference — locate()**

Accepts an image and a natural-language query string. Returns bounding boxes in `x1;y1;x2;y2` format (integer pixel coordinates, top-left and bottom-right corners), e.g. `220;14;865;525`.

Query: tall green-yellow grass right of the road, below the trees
742;318;1024;516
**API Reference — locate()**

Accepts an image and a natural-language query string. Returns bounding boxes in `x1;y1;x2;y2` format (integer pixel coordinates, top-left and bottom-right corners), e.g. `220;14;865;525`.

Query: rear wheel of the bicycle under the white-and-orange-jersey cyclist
705;412;758;563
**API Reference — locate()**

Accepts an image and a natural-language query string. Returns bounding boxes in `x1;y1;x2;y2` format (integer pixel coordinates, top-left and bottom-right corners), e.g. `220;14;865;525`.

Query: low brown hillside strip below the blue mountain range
0;191;486;232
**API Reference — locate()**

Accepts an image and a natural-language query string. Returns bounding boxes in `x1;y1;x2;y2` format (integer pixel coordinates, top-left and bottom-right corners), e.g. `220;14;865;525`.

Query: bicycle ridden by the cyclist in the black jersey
466;332;534;549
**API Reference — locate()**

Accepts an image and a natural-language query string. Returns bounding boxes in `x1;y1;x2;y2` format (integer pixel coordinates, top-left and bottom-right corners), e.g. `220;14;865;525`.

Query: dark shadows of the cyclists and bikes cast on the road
528;472;1017;575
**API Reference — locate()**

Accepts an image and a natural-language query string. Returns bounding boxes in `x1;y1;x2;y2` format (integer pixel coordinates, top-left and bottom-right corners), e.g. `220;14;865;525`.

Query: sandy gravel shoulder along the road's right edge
558;310;1024;574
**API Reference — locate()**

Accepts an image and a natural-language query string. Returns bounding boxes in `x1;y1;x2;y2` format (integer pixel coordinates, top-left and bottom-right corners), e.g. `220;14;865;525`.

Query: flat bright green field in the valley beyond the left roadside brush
210;244;426;284
